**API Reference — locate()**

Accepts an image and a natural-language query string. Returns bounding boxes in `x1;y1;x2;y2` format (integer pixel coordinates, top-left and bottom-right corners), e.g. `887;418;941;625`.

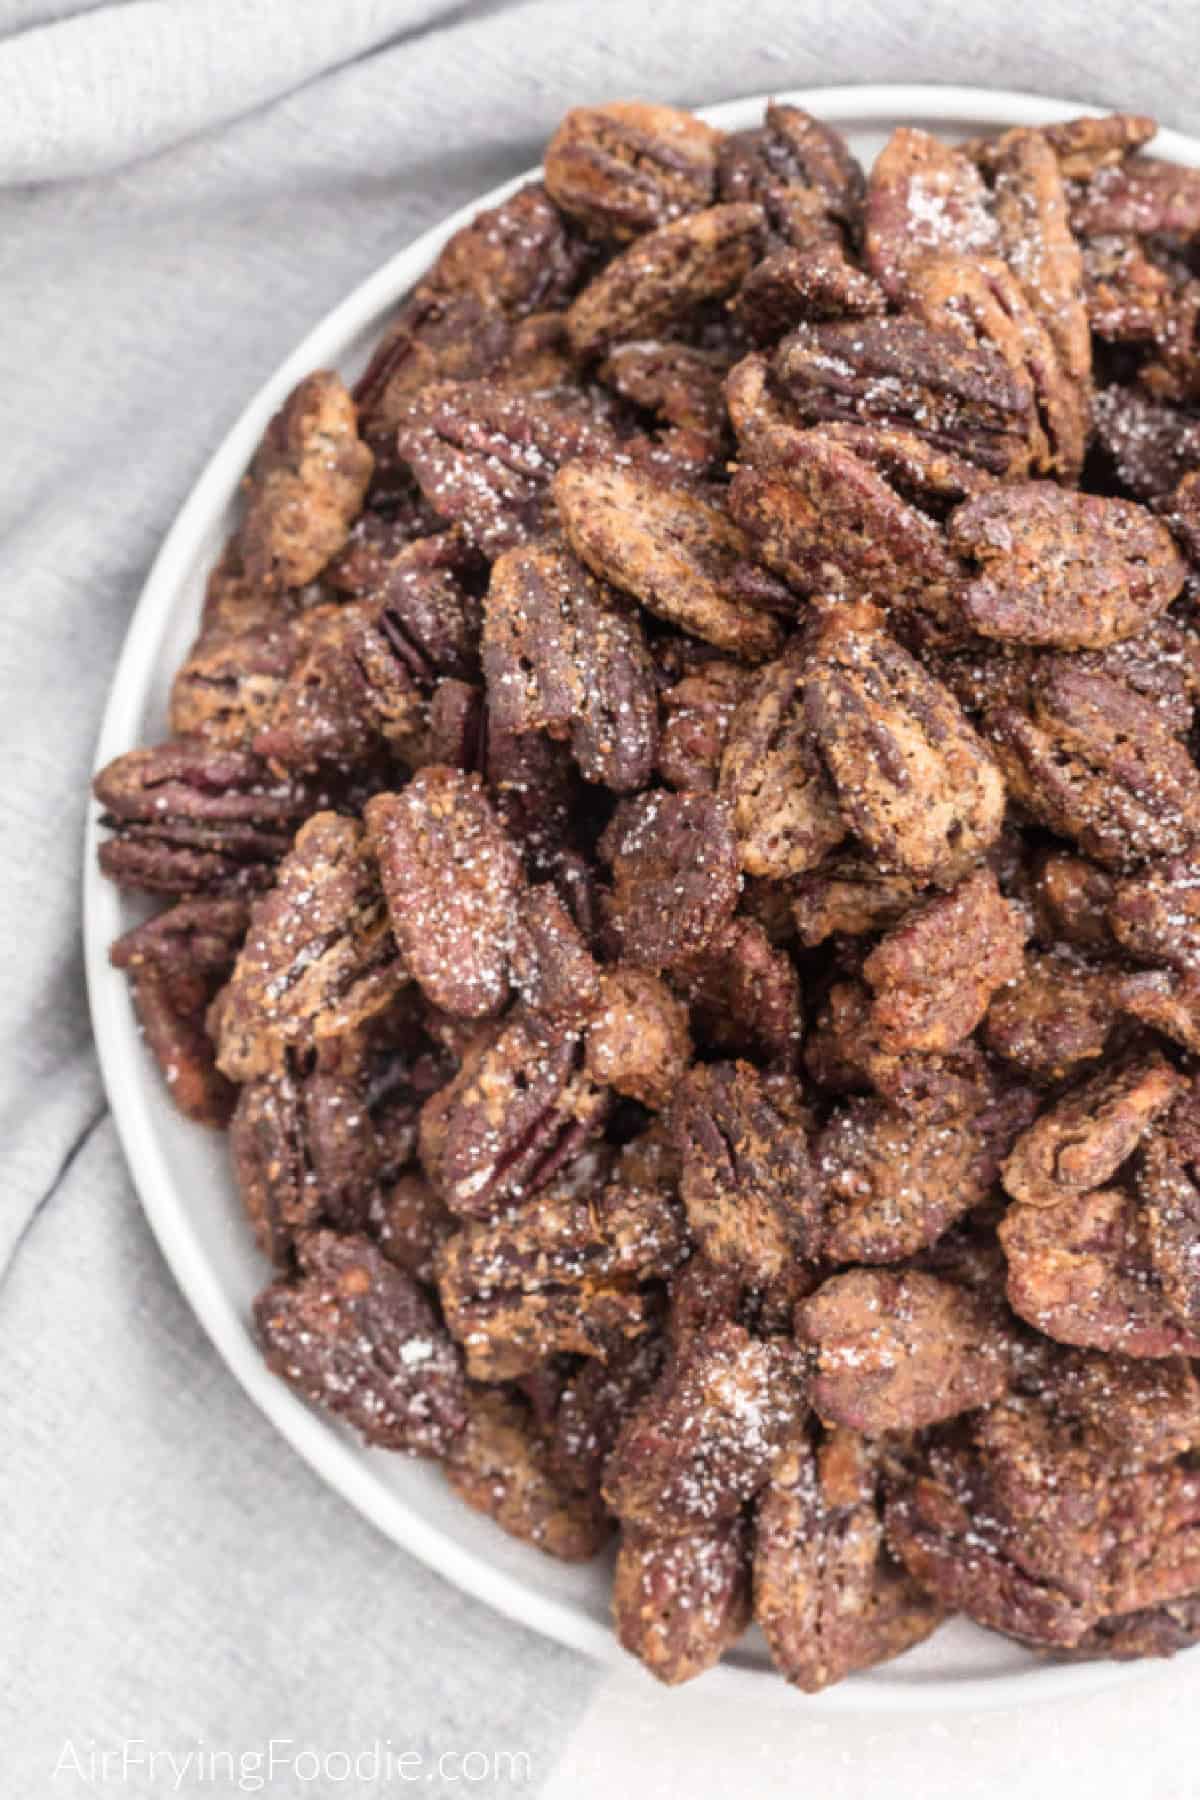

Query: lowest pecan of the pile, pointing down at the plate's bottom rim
754;1429;943;1694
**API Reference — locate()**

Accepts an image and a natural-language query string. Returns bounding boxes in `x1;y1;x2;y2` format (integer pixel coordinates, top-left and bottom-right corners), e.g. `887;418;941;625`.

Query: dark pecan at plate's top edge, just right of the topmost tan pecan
716;101;865;245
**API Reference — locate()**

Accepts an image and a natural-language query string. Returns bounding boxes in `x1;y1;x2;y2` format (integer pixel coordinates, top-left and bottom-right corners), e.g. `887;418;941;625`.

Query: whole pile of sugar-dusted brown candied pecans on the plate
95;103;1200;1690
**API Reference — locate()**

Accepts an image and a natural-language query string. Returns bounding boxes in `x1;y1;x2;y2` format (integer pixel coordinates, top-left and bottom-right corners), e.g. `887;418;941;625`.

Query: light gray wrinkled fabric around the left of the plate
0;0;1200;1800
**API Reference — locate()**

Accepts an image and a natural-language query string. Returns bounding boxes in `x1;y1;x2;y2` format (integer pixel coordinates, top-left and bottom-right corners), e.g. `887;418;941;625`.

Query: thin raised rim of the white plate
83;83;1200;1714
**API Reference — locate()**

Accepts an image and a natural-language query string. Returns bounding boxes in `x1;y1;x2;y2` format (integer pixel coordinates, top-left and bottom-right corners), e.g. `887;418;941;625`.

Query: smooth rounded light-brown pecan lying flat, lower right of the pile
795;1269;1013;1436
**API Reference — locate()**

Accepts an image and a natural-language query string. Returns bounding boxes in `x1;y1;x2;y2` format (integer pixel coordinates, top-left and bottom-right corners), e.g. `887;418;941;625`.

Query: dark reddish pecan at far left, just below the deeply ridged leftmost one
108;898;248;1127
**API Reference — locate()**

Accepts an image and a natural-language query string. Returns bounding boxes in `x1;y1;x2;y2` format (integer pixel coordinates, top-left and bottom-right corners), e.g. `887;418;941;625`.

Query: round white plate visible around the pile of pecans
85;86;1200;1712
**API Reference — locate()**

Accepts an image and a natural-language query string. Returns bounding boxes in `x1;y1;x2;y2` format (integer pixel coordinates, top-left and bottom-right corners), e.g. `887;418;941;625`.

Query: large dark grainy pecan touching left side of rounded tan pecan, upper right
729;427;963;635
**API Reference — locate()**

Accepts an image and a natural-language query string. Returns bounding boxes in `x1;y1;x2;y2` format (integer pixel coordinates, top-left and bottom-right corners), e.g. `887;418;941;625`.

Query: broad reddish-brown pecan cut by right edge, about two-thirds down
999;1188;1200;1357
